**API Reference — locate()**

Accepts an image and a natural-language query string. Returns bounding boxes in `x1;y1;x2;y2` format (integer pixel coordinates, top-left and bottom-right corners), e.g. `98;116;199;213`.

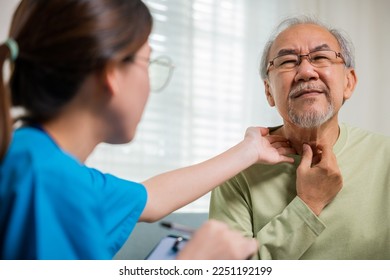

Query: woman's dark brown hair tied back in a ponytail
0;0;152;160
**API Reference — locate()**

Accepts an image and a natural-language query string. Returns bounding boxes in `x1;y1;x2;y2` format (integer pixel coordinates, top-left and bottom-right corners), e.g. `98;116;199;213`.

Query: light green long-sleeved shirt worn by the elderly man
210;124;390;259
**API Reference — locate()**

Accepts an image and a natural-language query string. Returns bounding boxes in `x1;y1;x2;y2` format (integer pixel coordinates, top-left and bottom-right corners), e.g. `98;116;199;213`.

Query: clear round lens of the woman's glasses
149;56;173;92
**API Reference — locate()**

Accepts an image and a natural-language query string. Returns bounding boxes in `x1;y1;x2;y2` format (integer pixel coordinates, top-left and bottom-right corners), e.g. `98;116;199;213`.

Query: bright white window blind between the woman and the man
87;0;280;212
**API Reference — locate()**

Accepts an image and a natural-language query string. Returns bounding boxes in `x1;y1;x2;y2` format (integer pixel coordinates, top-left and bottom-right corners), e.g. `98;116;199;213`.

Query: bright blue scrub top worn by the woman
0;127;147;259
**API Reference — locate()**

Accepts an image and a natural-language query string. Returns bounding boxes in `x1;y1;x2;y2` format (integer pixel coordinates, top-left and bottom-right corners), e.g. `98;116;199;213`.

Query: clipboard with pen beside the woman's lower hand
145;234;189;260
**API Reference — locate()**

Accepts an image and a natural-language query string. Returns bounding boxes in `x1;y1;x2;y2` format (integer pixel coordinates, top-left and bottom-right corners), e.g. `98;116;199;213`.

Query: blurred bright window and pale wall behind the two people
0;0;390;213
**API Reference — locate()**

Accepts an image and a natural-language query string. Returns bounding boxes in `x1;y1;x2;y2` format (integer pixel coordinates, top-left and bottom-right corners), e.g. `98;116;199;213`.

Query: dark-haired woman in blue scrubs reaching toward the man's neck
0;0;293;259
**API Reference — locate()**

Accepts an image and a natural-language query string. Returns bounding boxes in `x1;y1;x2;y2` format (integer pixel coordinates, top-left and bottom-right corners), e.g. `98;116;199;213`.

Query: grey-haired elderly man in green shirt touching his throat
210;17;390;259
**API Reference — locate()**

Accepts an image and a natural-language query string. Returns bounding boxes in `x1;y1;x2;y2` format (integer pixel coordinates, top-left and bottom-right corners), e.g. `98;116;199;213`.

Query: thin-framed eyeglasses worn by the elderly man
267;50;345;74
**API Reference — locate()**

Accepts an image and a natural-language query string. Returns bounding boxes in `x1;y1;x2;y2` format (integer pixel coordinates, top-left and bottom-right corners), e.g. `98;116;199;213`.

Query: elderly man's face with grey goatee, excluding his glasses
265;24;356;128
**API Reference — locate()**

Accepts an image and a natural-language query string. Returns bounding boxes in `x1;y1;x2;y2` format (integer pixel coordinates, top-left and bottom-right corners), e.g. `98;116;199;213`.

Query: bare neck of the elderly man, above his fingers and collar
275;119;340;155
